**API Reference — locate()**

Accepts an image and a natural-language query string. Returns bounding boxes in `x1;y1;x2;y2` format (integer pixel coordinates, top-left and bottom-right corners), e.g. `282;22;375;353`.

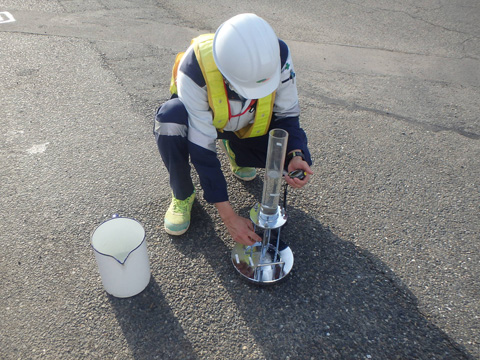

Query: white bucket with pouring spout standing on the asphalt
91;215;150;298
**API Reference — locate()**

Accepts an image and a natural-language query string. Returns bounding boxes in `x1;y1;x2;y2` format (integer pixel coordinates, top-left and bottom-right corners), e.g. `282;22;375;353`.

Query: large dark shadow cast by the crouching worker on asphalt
175;198;471;359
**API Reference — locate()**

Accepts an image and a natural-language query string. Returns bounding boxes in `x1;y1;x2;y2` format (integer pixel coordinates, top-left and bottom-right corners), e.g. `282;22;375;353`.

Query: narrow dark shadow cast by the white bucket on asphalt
108;276;197;359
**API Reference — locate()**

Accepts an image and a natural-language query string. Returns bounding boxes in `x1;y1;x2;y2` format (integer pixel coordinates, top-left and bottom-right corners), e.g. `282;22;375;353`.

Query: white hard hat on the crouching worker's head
213;14;281;99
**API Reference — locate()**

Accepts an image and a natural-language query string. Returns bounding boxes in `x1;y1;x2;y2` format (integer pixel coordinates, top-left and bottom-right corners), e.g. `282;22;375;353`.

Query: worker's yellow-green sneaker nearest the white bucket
164;191;195;235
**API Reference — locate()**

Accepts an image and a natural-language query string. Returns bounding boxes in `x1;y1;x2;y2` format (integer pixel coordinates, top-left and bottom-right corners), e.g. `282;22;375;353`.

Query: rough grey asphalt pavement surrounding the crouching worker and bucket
0;0;480;360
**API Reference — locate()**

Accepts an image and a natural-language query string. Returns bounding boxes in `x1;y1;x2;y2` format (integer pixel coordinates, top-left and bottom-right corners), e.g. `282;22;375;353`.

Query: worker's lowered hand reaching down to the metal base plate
215;201;262;246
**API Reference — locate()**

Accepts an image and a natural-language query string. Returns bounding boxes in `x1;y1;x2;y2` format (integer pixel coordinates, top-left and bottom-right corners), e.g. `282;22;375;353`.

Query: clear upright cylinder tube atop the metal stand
260;129;288;216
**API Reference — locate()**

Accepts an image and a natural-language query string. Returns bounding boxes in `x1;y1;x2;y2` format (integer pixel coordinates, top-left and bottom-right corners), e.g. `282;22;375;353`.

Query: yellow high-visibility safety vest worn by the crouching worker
170;34;275;139
